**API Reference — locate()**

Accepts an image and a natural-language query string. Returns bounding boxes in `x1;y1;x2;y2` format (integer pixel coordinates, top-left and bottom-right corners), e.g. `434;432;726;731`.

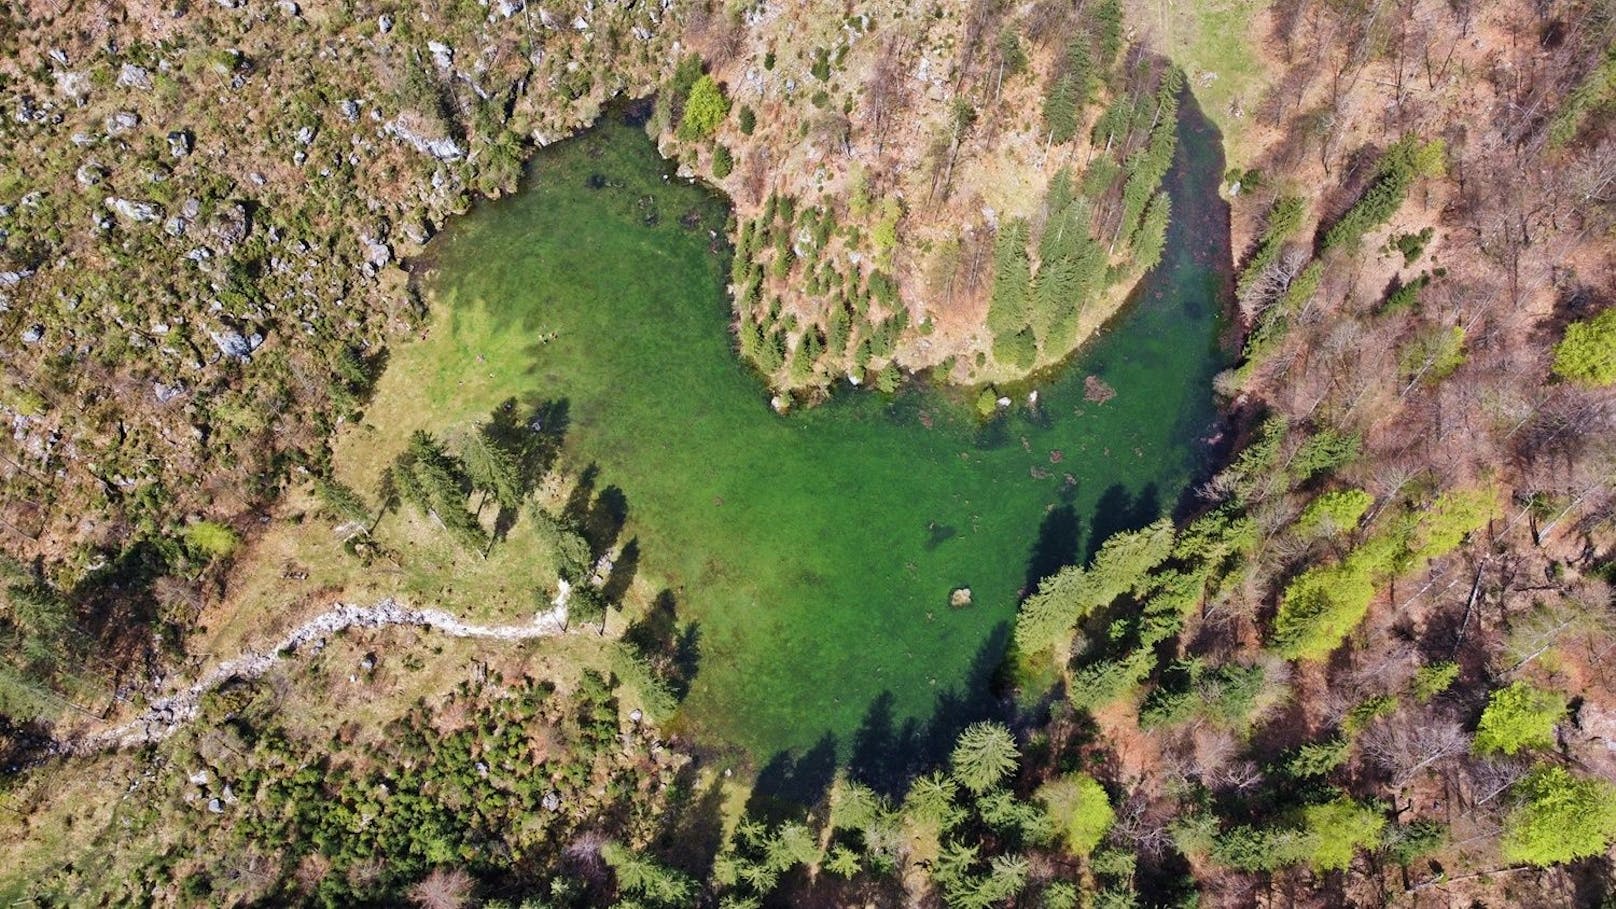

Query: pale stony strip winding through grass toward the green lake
71;581;570;754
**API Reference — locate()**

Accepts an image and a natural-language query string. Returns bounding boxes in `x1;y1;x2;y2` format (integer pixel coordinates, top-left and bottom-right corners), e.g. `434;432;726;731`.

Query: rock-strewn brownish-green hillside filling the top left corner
0;0;674;587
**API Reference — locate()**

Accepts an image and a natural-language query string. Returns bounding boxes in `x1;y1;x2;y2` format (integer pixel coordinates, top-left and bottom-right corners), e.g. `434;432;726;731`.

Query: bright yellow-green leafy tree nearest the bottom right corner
1501;767;1616;865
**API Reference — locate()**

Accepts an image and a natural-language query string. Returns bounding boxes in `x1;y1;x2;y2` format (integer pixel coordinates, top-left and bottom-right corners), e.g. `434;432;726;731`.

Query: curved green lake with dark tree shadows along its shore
435;97;1228;763
